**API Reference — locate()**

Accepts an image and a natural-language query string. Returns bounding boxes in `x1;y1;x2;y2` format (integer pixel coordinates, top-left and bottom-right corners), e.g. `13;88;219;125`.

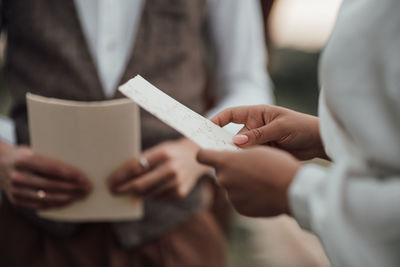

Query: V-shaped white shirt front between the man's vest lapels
74;0;144;97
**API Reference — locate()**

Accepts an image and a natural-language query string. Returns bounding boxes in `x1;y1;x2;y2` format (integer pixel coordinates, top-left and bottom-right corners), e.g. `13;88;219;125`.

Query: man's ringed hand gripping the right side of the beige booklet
108;138;209;200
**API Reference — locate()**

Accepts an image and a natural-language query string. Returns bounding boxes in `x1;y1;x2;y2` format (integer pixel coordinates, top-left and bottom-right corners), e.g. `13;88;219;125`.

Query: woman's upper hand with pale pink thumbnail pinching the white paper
212;105;328;160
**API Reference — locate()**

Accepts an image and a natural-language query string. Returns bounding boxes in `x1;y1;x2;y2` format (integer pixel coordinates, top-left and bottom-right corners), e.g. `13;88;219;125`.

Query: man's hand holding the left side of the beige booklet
0;142;91;210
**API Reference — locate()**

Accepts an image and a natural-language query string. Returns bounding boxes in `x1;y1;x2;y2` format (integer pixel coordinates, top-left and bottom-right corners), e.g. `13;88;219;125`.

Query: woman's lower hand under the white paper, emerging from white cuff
197;147;300;217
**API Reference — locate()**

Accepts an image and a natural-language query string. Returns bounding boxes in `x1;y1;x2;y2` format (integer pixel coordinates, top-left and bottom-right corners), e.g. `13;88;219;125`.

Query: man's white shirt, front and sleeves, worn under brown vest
0;0;274;142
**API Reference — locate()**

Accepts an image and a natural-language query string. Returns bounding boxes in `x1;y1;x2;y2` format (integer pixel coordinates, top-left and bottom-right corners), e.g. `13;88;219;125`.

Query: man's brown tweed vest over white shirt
2;0;206;248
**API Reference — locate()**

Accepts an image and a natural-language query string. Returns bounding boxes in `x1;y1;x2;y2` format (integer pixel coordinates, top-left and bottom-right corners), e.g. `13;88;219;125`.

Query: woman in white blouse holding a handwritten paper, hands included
198;0;400;266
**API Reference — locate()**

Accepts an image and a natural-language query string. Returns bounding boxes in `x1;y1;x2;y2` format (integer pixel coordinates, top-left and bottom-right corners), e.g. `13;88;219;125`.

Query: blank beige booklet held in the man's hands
27;94;143;222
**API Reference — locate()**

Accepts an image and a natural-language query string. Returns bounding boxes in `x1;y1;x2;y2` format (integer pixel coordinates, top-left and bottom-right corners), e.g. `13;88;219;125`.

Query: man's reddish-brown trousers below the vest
0;205;226;267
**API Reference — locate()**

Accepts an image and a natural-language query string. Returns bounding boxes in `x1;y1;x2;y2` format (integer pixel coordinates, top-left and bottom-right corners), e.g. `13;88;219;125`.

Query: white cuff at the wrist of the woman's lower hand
289;164;326;230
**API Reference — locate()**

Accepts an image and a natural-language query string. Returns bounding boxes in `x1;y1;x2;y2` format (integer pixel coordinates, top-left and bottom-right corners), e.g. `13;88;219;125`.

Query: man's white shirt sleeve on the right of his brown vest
207;0;274;133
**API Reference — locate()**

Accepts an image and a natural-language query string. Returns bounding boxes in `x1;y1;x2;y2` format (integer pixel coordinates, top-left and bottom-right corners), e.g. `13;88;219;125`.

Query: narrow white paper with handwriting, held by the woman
119;75;239;150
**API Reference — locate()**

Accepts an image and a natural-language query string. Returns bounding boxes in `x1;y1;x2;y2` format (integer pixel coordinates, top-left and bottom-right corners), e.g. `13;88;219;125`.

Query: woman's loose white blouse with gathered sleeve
289;0;400;267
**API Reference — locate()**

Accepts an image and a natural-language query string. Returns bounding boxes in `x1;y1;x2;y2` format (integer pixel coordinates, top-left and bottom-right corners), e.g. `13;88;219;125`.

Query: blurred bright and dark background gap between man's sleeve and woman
263;0;342;114
